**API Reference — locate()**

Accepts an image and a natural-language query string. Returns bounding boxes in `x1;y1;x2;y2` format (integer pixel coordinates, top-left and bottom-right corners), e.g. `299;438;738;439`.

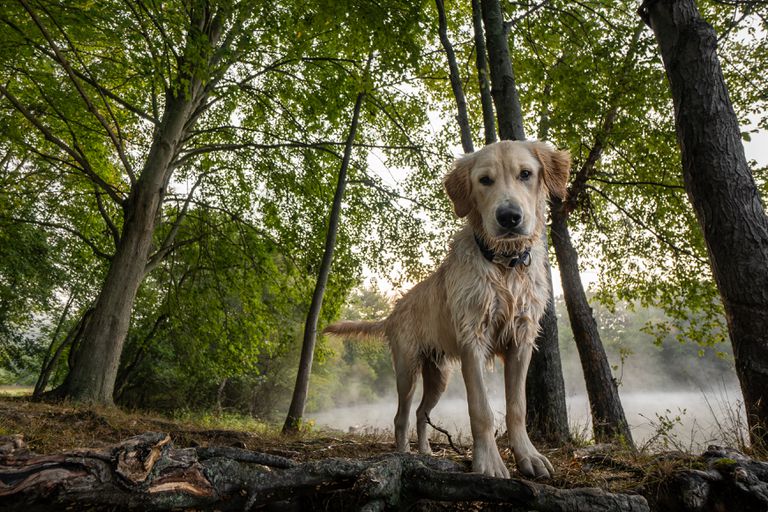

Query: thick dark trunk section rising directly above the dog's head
481;0;525;140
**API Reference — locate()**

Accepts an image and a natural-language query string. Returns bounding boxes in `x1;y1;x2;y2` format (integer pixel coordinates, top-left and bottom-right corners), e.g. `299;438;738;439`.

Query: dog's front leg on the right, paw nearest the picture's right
504;342;554;478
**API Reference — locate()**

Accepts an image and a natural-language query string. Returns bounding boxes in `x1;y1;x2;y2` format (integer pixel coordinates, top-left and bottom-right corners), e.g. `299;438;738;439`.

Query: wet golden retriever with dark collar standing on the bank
324;141;570;478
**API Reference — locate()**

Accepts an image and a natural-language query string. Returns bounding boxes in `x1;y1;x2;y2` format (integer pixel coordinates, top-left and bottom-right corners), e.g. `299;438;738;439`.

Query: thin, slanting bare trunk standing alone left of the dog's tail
283;91;370;434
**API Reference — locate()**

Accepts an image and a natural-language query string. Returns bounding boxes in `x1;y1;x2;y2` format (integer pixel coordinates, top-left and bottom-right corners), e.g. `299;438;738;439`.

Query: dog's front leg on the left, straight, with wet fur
461;344;509;478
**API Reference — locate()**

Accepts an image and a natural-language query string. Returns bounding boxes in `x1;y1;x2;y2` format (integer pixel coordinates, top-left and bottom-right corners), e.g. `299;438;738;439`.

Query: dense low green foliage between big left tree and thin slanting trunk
118;209;354;415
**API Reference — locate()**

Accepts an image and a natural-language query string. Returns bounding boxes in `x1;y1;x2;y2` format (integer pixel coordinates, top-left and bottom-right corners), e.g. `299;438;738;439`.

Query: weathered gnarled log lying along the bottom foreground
0;432;649;512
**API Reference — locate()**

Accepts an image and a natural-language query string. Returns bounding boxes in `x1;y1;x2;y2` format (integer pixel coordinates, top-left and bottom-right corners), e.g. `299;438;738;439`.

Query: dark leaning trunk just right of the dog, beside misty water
551;199;633;446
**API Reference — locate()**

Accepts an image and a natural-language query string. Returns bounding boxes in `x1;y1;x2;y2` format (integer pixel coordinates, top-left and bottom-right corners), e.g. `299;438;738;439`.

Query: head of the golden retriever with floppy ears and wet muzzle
445;141;571;242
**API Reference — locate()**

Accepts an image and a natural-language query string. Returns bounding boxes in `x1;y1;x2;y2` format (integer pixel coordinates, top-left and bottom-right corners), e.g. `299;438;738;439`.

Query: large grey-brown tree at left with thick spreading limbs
0;0;242;404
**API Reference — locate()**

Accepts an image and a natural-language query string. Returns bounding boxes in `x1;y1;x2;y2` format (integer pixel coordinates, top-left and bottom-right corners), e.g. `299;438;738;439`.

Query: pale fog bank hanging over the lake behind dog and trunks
308;326;746;451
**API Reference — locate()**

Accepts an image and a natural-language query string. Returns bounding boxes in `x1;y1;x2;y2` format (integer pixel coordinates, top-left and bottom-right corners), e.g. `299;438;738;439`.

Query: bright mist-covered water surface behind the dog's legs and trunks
308;360;746;452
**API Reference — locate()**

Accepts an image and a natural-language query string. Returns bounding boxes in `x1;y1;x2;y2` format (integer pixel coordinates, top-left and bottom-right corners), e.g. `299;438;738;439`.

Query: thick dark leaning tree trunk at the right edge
640;0;768;446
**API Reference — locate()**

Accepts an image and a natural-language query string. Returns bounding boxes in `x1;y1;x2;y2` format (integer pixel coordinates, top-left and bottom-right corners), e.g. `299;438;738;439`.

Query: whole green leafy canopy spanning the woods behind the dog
0;0;768;424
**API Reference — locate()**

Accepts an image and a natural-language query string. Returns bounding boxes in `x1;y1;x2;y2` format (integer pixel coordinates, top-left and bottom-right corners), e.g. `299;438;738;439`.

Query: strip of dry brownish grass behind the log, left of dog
0;397;393;460
